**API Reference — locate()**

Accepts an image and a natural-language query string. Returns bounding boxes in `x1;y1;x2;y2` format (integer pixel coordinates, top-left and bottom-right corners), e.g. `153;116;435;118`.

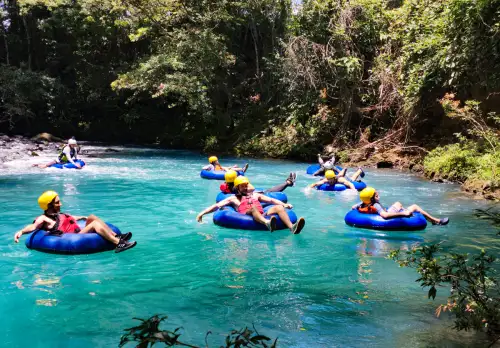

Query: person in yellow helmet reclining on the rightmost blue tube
352;187;450;225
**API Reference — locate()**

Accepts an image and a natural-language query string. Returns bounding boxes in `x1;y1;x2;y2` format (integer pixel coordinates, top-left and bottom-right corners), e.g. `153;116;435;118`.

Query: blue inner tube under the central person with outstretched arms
213;205;297;231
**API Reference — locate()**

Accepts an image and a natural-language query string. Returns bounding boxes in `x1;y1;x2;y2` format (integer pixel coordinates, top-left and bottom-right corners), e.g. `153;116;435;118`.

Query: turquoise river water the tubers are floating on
0;149;499;347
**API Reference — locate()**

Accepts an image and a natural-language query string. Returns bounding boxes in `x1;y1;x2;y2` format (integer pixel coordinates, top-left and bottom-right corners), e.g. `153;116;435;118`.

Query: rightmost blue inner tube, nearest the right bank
344;209;427;231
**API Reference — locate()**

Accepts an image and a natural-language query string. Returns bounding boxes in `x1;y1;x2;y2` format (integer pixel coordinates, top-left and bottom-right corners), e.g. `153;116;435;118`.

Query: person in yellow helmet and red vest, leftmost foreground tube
14;191;137;253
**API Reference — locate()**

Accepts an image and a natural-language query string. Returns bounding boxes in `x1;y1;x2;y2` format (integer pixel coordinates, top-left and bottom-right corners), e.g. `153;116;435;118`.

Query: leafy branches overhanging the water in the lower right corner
389;244;500;341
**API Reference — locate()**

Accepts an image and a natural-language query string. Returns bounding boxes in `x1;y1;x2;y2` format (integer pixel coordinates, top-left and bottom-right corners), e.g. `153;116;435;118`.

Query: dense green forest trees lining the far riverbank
0;0;500;185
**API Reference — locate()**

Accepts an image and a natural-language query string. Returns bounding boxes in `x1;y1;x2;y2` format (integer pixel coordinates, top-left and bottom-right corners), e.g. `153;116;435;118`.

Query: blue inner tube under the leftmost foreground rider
26;220;121;254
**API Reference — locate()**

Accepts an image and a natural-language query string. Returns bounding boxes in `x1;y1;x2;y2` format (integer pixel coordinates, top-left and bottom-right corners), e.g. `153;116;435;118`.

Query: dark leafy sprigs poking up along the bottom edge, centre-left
118;315;278;348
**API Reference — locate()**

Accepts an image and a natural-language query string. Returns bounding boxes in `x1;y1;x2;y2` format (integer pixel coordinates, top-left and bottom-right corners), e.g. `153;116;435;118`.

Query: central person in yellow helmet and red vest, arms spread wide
196;176;306;234
